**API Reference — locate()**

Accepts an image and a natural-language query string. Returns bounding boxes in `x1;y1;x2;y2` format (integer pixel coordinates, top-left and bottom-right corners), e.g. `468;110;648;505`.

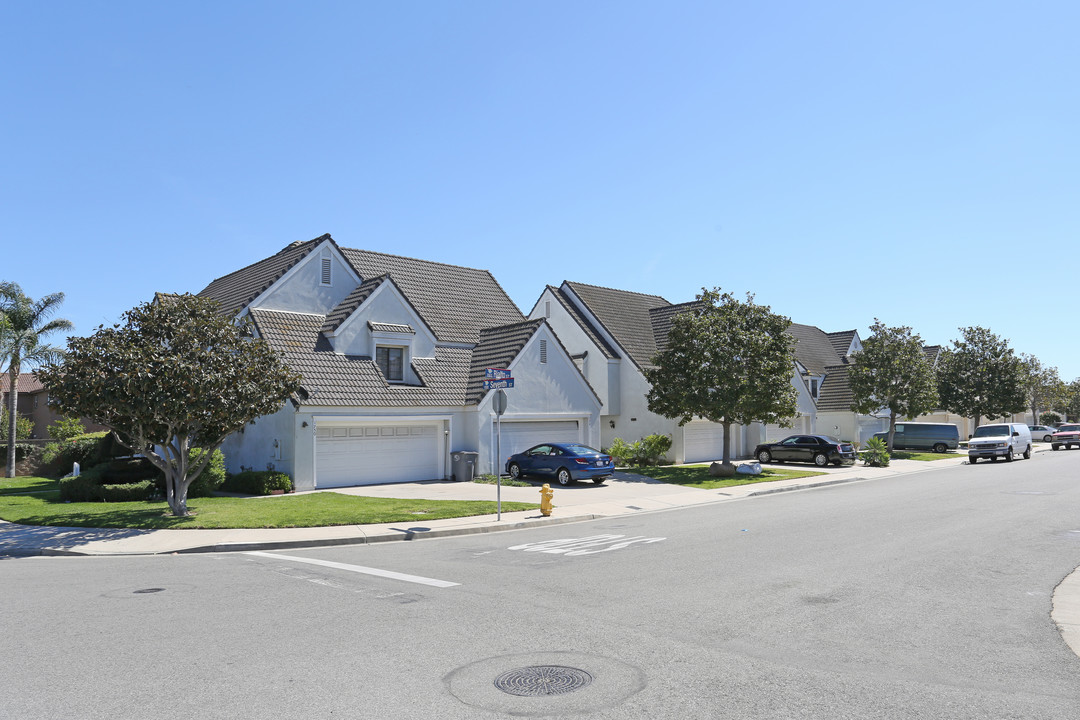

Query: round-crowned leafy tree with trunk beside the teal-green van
848;318;937;452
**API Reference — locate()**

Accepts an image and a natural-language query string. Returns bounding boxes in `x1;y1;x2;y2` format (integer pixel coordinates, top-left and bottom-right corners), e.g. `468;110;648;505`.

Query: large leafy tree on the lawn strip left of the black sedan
645;287;798;465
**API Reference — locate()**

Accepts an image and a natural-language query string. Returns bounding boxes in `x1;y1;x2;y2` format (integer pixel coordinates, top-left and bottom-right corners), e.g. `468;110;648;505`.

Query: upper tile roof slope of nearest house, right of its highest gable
340;247;525;343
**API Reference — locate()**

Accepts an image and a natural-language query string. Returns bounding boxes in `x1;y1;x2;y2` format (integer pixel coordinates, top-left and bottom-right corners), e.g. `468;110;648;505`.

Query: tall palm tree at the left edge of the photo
0;283;72;477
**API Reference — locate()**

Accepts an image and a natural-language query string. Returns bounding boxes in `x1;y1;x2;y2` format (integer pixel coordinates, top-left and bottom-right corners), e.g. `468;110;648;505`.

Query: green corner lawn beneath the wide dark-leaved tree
0;477;539;529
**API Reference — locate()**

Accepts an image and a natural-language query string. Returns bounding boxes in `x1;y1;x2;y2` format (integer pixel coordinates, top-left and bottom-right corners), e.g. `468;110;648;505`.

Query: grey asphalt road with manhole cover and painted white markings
0;452;1080;720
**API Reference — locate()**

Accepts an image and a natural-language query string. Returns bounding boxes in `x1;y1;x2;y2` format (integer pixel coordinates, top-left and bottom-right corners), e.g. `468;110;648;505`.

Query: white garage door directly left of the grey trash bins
315;423;443;488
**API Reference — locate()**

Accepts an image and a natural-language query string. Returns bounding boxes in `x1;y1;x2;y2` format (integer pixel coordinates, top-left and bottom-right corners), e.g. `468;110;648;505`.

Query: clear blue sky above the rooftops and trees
0;0;1080;380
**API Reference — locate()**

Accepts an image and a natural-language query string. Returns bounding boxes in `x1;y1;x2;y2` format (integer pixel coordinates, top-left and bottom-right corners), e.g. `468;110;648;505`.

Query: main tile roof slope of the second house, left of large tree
564;281;671;369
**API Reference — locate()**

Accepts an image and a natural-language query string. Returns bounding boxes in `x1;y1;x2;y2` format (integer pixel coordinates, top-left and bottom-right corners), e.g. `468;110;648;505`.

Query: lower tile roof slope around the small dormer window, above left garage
251;309;472;407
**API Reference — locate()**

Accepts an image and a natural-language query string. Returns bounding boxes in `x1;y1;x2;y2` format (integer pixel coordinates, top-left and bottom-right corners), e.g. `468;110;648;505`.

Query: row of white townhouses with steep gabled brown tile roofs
190;234;883;489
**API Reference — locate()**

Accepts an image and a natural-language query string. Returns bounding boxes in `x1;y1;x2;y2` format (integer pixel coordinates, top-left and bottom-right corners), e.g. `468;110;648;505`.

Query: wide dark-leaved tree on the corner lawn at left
38;295;300;516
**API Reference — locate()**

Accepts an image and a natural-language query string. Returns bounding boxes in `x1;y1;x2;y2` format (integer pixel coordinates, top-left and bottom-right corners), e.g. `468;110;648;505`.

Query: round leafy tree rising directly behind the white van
937;326;1027;427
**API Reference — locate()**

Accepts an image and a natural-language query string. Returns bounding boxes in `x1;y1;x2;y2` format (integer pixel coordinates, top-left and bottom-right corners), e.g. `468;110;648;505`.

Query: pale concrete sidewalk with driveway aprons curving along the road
0;454;967;556
